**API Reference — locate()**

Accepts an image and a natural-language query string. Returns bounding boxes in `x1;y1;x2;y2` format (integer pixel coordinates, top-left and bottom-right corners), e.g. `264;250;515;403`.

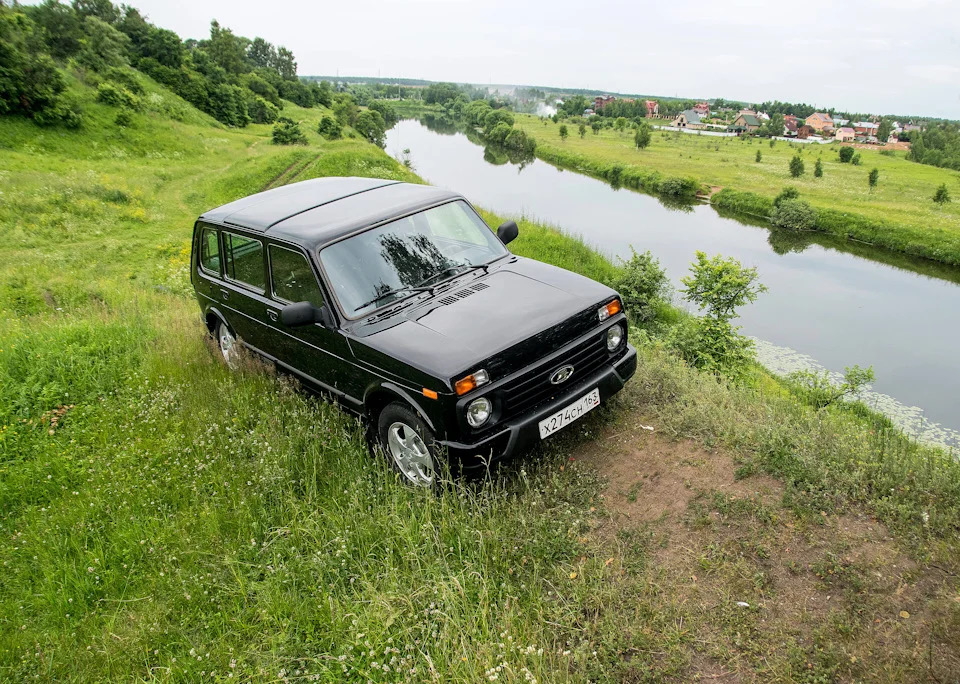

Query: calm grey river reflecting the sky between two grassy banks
387;120;960;445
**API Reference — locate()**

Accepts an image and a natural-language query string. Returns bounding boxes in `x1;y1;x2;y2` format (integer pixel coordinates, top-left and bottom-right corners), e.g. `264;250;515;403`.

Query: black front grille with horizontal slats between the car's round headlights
501;332;609;420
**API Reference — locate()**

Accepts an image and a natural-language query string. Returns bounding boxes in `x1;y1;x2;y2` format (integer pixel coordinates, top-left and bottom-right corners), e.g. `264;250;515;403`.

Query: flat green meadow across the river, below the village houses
516;115;960;265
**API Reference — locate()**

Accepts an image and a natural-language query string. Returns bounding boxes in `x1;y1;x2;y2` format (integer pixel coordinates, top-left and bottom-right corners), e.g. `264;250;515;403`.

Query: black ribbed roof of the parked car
200;177;461;249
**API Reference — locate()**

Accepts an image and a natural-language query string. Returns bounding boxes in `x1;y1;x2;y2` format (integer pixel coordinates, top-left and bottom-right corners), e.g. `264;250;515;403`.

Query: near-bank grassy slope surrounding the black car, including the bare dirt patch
0;72;960;682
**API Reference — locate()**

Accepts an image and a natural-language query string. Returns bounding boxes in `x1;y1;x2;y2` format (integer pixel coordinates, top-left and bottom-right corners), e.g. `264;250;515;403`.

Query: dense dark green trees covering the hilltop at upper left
0;0;332;127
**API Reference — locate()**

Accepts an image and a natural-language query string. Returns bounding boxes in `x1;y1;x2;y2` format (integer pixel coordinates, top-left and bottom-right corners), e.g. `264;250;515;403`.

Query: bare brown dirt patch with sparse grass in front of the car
574;419;960;682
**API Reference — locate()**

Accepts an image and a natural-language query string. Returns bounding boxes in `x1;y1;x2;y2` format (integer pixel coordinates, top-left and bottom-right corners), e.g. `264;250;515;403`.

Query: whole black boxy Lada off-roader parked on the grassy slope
191;178;636;485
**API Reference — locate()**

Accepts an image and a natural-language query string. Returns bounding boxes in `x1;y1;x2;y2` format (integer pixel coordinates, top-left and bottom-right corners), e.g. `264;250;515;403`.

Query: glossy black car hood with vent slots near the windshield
355;257;616;380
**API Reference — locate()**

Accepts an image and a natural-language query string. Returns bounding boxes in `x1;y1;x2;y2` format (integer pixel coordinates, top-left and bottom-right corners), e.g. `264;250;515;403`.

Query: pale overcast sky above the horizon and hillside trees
112;0;960;118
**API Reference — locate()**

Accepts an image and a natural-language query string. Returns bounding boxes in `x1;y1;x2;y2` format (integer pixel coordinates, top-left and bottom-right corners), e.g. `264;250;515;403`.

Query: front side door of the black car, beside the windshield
267;243;360;402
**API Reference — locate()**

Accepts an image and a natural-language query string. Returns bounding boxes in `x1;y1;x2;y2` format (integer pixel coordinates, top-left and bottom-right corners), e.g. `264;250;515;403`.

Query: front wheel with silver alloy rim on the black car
377;401;438;487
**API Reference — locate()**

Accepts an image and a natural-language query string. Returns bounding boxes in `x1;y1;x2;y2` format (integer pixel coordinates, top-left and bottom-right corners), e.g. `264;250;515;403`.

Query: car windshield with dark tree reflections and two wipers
320;200;508;318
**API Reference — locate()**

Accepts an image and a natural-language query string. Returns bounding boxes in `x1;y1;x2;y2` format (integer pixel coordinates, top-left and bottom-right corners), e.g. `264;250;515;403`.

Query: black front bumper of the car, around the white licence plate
440;344;637;470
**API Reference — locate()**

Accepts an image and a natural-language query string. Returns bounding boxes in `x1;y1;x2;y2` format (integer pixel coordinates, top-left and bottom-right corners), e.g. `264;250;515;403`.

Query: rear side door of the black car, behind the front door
220;229;272;354
